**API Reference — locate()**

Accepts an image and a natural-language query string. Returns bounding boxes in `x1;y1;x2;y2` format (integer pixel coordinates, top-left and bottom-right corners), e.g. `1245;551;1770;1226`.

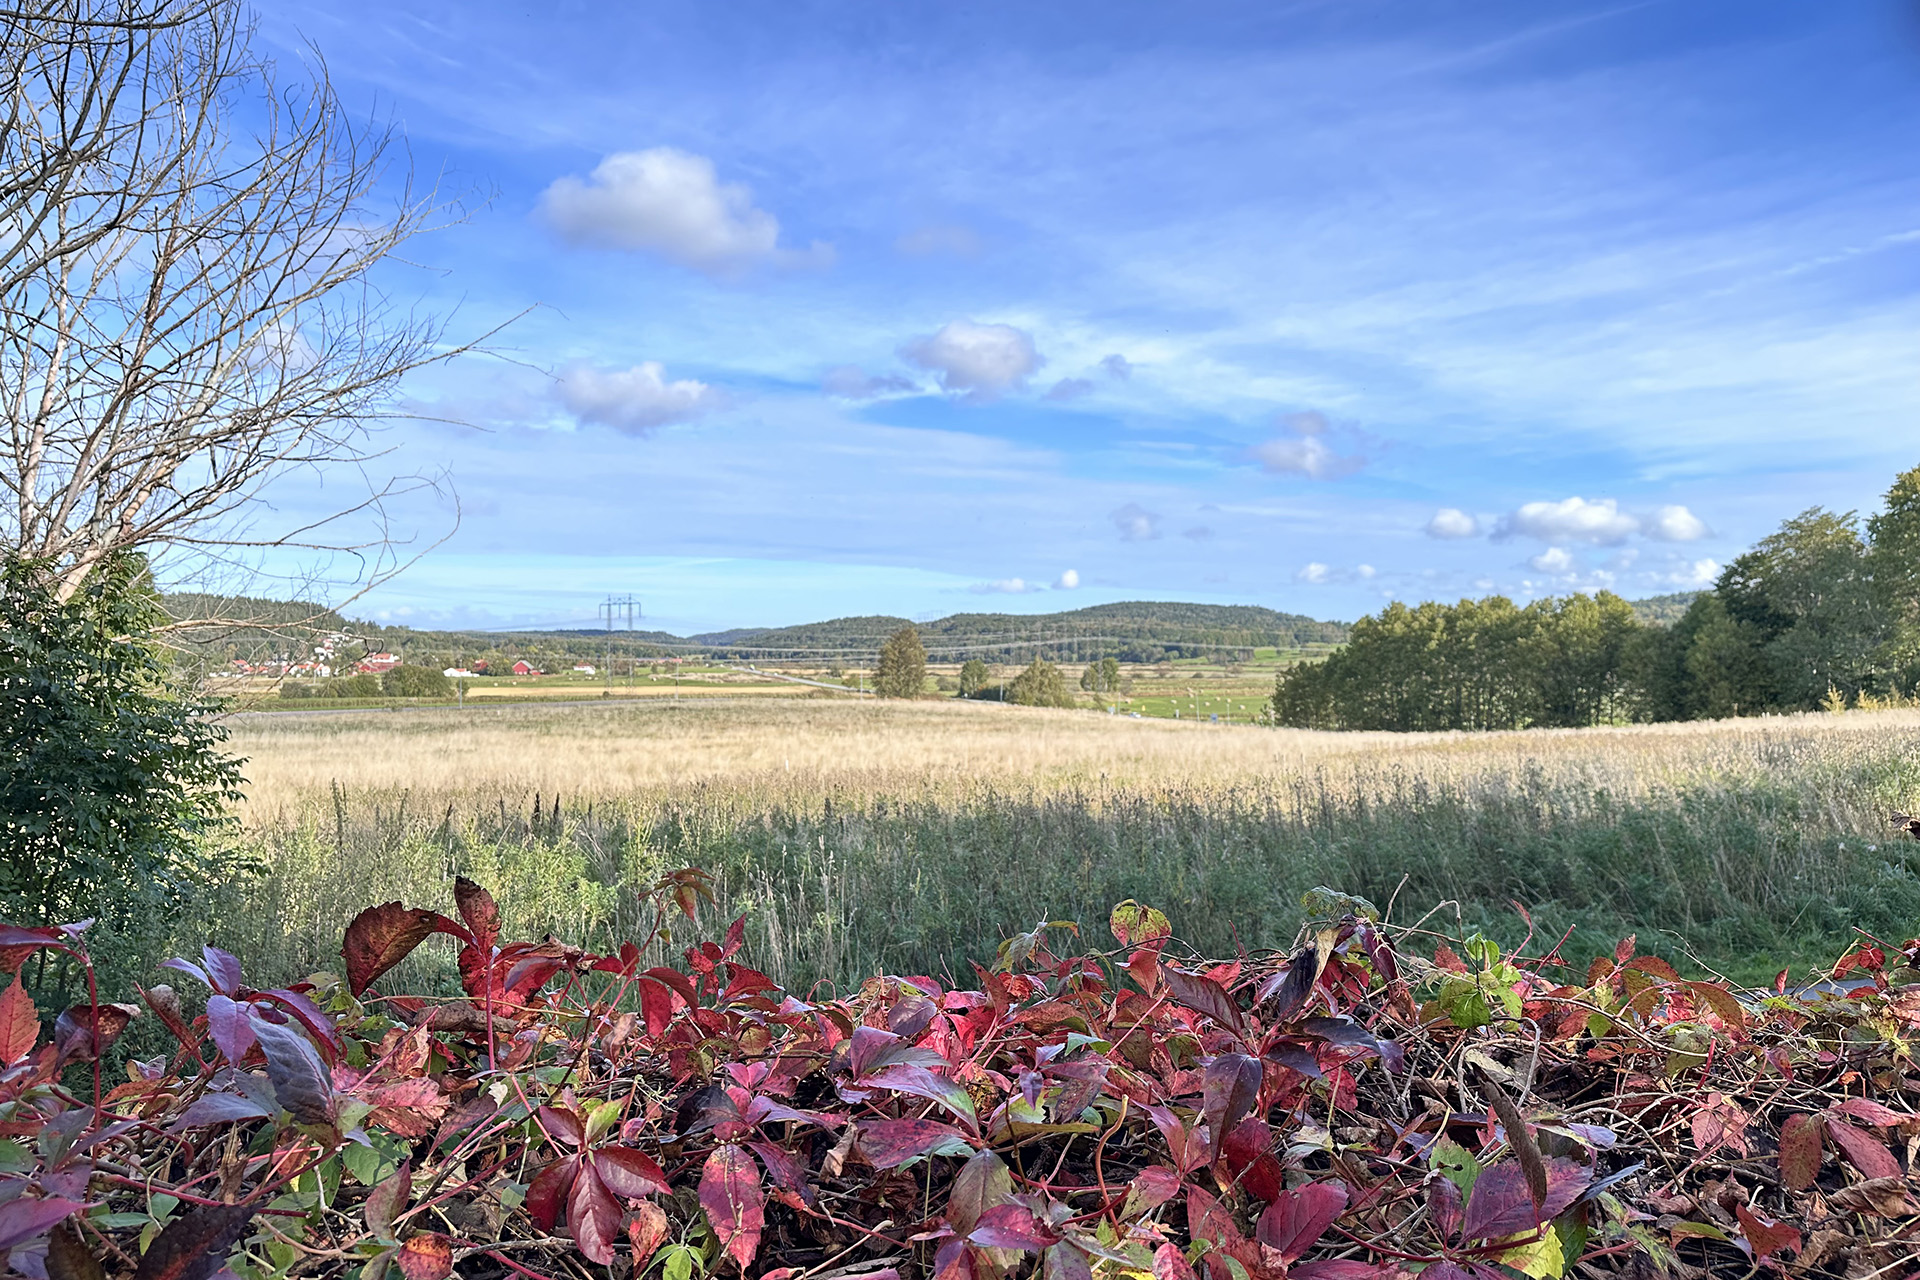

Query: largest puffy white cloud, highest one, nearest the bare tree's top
540;146;831;274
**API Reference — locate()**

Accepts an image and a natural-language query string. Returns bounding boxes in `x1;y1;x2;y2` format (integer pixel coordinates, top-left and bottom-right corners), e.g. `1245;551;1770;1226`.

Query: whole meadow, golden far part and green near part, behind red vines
210;699;1920;988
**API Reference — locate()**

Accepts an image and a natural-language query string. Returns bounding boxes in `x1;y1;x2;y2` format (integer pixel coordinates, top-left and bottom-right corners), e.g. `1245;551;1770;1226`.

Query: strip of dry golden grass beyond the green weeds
232;699;1920;814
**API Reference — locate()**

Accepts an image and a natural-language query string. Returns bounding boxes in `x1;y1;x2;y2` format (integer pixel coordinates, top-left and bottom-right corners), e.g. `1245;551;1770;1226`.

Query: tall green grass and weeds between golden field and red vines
187;729;1920;986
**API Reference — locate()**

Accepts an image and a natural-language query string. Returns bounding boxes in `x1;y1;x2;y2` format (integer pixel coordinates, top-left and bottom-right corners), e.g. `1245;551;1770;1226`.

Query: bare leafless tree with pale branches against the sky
0;0;480;599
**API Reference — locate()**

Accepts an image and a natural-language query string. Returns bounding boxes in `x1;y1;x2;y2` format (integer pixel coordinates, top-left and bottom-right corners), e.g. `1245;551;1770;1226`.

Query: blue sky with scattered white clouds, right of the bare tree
261;0;1920;631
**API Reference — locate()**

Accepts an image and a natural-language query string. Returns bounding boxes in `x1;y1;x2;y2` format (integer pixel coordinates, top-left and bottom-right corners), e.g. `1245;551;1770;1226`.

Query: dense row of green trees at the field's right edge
1273;468;1920;731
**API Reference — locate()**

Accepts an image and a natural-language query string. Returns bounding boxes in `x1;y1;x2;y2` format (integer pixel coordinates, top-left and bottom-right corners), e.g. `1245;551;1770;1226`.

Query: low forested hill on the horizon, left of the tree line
691;601;1346;662
